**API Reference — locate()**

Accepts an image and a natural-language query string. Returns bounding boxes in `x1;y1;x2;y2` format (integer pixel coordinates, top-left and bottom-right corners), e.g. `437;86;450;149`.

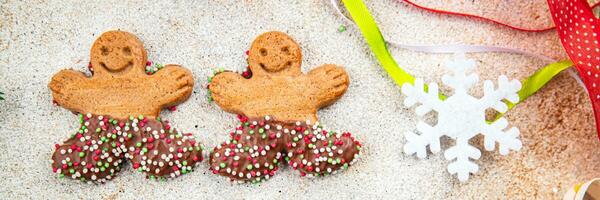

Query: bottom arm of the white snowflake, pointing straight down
444;137;481;182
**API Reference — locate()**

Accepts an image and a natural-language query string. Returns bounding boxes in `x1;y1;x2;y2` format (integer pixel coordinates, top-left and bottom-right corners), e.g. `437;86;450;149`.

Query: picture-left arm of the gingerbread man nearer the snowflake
208;72;252;114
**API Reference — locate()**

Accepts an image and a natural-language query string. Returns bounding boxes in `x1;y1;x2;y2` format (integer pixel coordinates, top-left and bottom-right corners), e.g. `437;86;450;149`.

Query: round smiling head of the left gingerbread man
90;31;147;75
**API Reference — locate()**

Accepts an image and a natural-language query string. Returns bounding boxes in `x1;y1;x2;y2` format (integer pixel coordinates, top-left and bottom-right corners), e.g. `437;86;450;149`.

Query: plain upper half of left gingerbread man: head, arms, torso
49;31;194;119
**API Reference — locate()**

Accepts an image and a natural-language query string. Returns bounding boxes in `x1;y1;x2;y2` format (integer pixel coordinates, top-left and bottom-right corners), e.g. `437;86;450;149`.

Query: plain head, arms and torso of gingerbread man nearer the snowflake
209;32;349;122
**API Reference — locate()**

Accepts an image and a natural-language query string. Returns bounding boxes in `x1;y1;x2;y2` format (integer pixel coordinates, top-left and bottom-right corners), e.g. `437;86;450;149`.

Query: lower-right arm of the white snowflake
481;118;523;155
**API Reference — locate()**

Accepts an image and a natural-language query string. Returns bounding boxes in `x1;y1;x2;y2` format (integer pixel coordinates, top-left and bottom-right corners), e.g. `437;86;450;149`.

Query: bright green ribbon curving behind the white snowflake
342;0;573;119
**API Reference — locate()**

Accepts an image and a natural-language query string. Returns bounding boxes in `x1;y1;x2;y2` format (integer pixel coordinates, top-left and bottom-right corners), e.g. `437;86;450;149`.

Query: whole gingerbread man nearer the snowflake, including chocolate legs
208;32;361;182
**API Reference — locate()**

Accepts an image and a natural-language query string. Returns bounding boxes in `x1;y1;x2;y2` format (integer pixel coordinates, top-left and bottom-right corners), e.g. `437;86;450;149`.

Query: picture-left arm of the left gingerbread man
48;69;89;112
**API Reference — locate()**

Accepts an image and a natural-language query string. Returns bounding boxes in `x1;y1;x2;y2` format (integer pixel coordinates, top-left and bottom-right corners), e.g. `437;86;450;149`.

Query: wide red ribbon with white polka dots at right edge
548;0;600;137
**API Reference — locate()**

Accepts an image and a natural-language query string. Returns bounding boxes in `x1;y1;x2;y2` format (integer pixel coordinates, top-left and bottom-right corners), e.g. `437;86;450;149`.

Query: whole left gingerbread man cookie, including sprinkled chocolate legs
49;31;202;182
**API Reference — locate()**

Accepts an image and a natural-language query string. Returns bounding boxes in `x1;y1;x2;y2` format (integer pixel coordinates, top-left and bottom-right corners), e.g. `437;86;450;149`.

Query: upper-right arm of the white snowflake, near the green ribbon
480;75;521;112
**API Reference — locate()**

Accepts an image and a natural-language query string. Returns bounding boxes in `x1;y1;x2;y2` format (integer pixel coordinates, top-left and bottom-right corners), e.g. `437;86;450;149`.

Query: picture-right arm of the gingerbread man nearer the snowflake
307;64;350;108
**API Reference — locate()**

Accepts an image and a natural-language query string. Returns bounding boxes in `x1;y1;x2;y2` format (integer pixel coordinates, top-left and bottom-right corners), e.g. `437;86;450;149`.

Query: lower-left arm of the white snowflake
404;122;443;158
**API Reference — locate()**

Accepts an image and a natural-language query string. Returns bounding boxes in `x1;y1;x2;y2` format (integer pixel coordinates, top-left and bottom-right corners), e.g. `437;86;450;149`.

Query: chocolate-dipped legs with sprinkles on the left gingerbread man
52;114;202;183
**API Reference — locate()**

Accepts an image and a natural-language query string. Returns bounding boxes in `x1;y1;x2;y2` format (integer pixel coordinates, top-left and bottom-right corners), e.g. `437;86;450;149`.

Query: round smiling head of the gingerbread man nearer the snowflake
248;31;302;76
